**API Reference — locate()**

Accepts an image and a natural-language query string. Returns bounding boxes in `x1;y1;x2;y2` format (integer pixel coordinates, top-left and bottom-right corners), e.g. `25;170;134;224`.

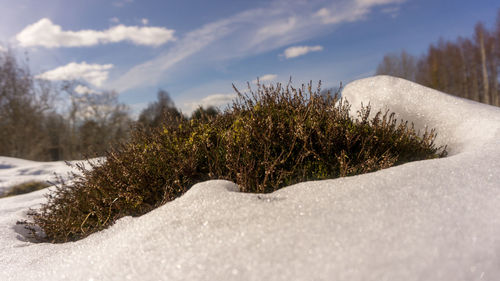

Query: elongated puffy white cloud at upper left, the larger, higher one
16;18;175;48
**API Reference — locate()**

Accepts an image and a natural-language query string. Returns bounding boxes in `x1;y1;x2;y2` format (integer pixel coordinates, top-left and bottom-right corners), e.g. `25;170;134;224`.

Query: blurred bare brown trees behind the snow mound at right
376;10;500;106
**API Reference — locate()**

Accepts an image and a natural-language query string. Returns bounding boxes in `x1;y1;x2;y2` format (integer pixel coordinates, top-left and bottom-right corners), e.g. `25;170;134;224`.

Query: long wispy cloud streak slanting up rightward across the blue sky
106;0;404;92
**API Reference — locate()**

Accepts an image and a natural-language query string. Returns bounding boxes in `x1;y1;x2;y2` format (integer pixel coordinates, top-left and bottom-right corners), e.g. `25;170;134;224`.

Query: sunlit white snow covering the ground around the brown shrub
0;76;500;280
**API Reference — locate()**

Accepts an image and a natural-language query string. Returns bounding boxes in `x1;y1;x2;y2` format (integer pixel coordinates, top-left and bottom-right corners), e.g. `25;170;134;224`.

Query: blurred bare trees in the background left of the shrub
0;50;216;161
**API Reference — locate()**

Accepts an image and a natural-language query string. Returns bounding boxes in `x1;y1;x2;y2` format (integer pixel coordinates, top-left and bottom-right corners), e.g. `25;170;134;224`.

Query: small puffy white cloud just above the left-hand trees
36;62;113;87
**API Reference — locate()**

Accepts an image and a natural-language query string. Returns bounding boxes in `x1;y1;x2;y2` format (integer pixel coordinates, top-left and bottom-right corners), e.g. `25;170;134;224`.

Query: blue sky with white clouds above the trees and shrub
0;0;500;113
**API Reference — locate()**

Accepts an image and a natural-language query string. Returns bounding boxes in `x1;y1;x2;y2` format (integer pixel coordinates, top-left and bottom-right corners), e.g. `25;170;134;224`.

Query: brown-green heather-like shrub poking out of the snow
22;81;446;242
